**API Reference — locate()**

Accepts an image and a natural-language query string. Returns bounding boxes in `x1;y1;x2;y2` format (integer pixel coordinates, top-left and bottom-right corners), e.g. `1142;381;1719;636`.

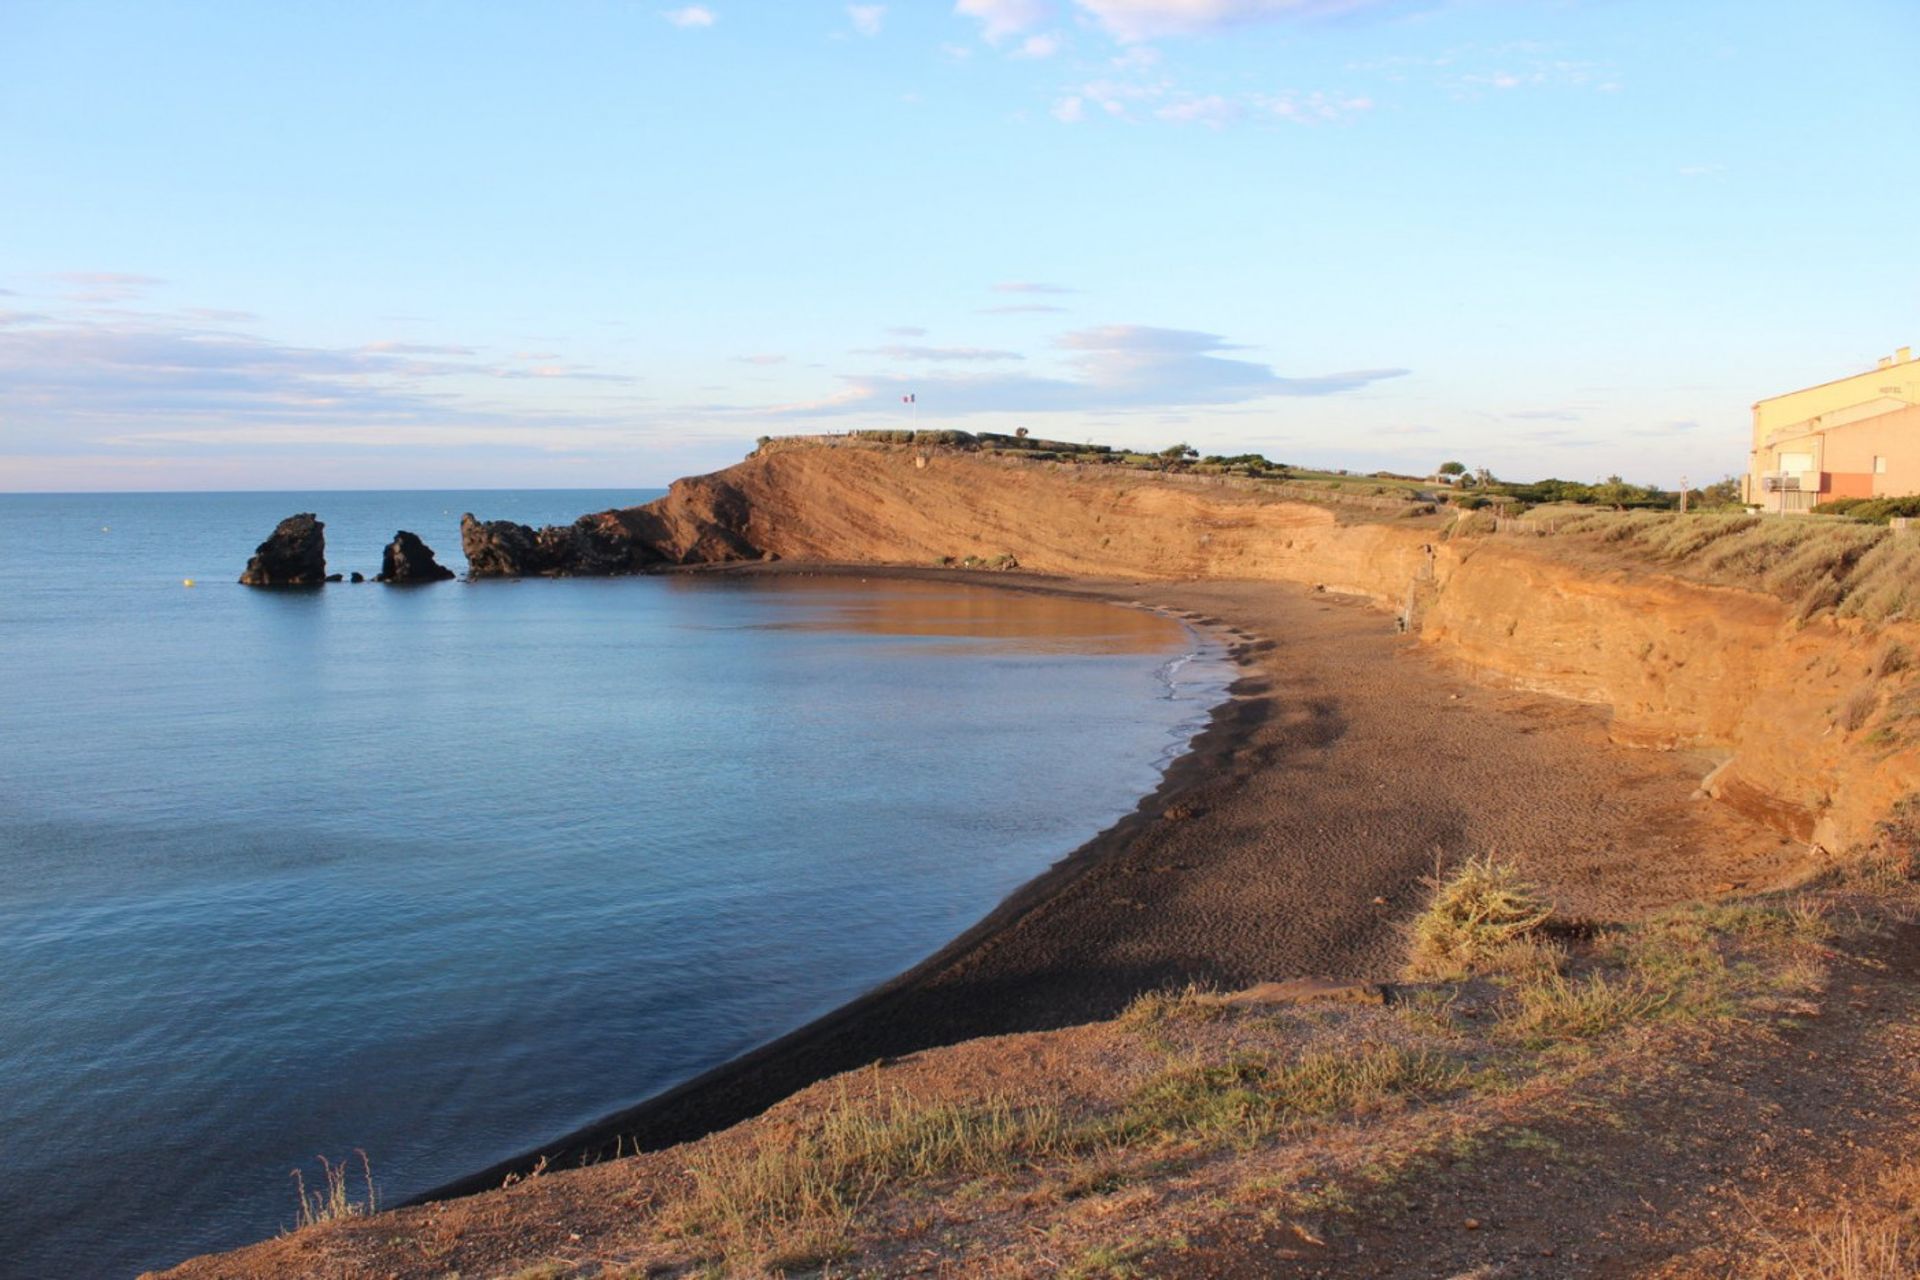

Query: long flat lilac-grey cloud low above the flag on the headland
780;324;1407;416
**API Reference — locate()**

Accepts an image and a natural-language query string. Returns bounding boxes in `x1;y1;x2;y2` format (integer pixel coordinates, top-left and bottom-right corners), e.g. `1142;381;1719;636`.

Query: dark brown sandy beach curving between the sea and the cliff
420;564;1799;1199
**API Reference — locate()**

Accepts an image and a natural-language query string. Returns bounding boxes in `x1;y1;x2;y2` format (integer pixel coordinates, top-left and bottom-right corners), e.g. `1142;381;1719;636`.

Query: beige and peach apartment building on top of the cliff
1741;347;1920;512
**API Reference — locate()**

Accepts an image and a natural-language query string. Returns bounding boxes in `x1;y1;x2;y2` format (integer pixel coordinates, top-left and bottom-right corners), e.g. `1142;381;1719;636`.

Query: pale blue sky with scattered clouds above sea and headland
0;0;1920;491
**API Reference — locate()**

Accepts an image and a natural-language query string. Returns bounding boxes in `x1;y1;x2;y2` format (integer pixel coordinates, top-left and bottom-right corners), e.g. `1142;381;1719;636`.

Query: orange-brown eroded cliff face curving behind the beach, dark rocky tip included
476;441;1920;852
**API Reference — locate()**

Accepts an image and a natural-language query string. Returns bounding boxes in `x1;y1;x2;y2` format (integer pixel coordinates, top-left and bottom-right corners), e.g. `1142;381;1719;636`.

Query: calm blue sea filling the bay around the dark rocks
0;491;1227;1276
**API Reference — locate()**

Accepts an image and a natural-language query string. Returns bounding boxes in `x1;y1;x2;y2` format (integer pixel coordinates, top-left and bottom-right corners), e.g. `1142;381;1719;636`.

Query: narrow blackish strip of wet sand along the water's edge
420;562;1258;1207
